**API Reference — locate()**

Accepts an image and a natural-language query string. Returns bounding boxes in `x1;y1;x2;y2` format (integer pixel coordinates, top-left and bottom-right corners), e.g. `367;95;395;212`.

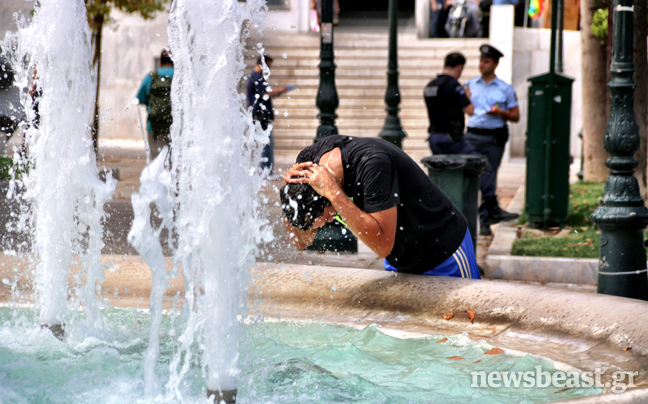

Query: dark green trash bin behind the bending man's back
421;154;488;250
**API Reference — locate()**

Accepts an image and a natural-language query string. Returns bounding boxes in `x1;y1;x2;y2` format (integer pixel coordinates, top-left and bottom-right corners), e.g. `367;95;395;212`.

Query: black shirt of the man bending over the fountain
297;135;468;274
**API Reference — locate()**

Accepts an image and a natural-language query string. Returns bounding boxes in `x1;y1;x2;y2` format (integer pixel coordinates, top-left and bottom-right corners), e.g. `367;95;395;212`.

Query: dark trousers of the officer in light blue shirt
464;132;504;218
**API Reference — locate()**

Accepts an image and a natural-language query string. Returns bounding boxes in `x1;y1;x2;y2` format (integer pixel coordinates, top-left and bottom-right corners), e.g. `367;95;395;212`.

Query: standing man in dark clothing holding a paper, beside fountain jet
246;55;291;181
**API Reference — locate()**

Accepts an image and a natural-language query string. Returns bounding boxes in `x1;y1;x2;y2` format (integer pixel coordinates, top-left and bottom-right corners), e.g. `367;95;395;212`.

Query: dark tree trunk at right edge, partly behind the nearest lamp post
634;0;648;200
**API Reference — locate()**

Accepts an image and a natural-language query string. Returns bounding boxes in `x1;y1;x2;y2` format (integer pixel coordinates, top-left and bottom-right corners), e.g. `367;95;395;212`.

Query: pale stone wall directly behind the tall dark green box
510;28;583;158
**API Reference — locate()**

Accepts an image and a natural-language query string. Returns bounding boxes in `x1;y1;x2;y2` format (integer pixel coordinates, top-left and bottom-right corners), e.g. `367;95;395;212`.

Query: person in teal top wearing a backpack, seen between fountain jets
137;48;173;159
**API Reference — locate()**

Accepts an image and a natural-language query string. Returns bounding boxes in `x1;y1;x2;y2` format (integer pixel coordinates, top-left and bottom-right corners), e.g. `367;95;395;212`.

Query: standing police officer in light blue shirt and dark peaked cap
464;45;520;235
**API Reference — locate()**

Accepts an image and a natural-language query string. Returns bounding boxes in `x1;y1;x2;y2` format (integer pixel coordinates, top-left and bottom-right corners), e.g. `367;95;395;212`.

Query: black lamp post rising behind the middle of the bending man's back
378;0;407;149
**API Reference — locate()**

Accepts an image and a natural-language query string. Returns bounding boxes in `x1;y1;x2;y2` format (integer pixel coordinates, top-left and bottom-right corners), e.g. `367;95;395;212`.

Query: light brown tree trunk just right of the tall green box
581;0;610;182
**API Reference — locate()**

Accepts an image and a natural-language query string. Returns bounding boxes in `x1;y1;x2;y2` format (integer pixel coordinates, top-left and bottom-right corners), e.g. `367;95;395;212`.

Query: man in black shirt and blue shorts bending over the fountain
280;136;480;279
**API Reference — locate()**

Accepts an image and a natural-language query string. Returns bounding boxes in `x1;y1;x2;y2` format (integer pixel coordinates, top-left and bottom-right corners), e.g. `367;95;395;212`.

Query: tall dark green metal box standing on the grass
525;73;574;227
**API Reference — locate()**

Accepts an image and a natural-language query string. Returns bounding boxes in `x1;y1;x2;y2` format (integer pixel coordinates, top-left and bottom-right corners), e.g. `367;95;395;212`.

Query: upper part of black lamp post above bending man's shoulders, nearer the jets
315;0;340;142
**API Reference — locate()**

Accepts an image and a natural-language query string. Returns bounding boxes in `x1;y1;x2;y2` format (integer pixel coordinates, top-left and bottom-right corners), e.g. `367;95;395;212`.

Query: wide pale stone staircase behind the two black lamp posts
246;30;484;161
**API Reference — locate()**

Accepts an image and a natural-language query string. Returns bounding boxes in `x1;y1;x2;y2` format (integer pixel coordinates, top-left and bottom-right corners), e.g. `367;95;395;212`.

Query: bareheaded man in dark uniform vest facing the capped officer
423;52;480;155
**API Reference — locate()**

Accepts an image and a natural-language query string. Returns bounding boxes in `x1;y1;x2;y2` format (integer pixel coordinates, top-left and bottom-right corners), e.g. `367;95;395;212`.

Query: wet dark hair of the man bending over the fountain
279;184;331;230
